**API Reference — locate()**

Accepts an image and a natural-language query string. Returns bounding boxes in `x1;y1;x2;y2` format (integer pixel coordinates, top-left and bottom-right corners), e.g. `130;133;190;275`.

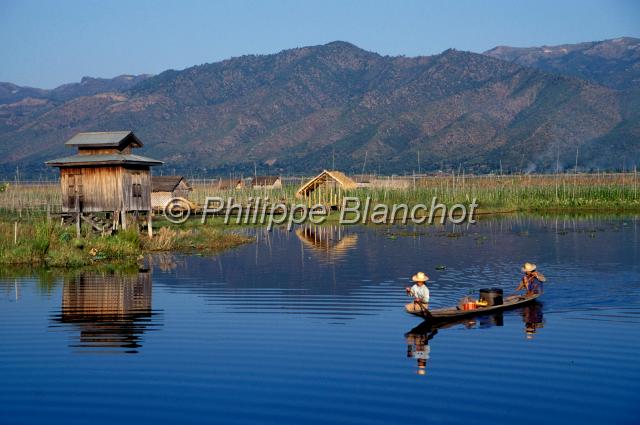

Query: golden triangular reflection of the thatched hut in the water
296;225;358;263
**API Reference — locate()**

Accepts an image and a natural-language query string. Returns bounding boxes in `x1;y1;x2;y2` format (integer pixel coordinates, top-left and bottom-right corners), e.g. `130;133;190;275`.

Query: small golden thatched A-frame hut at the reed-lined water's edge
296;170;358;208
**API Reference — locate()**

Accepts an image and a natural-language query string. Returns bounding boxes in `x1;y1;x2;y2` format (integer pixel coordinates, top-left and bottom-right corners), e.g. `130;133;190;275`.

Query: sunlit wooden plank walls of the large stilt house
60;166;151;212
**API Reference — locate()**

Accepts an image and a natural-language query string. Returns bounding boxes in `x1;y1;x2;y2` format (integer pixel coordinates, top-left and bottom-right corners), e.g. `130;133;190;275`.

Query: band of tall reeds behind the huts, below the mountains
0;172;640;216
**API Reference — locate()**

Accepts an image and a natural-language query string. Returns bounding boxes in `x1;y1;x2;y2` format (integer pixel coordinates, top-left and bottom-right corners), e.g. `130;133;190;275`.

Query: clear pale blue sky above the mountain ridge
0;0;640;88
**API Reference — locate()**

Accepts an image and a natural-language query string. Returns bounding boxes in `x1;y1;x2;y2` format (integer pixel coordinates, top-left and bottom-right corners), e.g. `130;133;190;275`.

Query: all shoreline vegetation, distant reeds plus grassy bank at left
0;172;640;268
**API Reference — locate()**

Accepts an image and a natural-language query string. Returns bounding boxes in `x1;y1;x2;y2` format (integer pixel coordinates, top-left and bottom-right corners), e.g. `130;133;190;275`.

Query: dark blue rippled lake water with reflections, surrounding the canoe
0;217;640;424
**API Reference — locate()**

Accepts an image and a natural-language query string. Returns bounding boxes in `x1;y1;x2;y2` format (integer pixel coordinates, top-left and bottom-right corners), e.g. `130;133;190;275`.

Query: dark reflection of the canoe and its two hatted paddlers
404;301;544;375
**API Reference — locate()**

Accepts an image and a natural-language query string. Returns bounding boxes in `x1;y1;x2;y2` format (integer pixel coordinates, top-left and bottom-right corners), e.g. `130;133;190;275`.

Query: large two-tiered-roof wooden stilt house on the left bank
46;131;162;235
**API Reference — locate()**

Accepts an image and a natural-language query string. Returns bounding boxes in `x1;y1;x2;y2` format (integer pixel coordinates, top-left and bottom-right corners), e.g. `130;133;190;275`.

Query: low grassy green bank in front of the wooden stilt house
0;215;252;267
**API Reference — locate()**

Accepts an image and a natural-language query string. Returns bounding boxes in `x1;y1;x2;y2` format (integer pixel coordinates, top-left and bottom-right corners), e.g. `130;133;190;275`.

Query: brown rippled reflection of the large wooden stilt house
52;270;159;353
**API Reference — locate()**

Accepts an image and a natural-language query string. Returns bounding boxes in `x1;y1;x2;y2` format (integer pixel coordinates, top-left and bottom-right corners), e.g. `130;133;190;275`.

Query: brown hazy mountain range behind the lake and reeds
0;38;640;176
